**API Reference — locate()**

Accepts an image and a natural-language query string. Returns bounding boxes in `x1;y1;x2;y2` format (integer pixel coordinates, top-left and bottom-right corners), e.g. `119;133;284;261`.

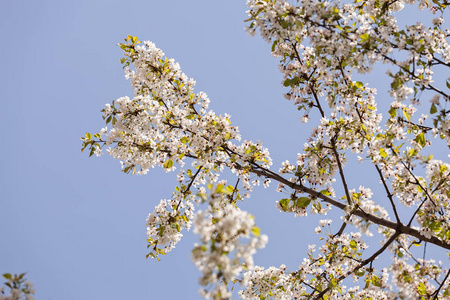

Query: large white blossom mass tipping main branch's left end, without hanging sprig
83;36;271;181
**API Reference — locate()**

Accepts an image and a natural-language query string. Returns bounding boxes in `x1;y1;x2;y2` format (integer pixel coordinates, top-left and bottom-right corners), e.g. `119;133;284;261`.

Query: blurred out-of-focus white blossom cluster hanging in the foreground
192;184;267;299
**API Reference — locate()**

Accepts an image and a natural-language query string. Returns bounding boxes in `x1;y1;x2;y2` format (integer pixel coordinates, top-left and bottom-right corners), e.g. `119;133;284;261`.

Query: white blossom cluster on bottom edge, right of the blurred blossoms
239;231;389;299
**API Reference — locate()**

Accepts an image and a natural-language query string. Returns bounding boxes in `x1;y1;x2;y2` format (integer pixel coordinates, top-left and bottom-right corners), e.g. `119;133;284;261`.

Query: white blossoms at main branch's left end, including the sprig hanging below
82;36;272;257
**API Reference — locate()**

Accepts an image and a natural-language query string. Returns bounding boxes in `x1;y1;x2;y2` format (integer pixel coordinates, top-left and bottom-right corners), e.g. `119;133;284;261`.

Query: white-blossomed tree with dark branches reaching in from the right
82;0;450;299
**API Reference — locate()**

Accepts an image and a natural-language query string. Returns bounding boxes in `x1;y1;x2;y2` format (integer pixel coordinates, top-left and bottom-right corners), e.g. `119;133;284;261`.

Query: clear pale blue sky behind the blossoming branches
0;0;448;300
